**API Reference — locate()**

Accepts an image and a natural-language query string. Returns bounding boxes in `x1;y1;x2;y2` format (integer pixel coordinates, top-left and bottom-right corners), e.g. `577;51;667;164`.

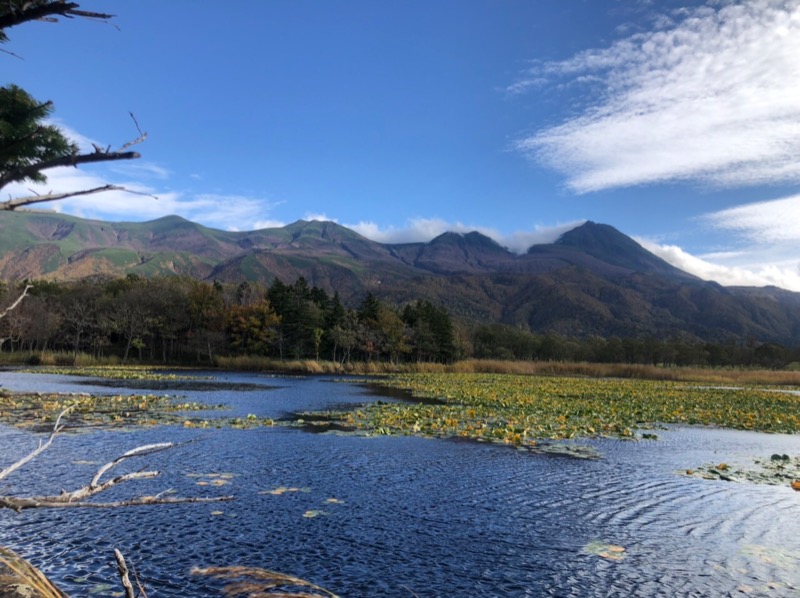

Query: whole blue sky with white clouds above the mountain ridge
0;0;800;291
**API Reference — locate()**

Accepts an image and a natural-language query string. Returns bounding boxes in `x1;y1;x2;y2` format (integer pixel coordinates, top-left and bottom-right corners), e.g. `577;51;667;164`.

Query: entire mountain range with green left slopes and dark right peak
0;211;800;344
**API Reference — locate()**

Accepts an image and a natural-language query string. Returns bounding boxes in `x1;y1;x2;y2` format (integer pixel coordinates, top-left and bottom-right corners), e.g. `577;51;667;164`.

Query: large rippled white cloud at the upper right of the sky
509;0;800;193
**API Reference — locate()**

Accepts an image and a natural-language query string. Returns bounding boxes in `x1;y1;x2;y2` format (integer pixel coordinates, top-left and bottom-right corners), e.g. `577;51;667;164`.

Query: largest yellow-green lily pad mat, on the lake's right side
327;374;800;446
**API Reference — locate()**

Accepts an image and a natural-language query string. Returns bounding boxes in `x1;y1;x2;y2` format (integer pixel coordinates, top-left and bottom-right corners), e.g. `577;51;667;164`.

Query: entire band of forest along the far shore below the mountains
0;275;800;369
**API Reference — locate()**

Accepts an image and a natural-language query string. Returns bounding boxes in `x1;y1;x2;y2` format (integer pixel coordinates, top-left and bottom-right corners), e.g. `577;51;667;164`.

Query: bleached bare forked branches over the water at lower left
0;407;233;512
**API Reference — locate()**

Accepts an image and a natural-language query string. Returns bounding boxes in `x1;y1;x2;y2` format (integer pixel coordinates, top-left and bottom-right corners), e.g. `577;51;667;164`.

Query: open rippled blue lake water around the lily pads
0;372;800;598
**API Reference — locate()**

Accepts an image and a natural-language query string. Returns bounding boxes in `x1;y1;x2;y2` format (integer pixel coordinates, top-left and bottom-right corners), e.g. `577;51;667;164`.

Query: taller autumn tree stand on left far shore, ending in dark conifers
0;275;460;364
